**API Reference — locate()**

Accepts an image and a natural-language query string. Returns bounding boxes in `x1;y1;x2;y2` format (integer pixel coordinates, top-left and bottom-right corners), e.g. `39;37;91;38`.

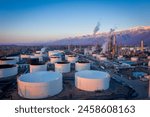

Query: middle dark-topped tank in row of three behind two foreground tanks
55;61;71;73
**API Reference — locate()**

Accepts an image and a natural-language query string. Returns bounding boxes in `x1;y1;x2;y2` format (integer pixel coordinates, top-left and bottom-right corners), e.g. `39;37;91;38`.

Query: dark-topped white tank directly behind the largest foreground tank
30;63;47;73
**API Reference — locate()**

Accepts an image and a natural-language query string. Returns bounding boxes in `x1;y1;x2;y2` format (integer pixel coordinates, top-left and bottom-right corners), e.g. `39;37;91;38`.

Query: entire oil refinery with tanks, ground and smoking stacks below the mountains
0;27;150;100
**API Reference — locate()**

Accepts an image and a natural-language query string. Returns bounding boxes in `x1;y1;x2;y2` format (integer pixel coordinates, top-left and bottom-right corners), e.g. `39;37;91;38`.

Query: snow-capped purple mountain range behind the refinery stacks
48;26;150;46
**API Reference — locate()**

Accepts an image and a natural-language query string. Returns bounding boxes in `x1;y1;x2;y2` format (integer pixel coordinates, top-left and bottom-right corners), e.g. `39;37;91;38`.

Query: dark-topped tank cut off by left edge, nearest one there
0;64;18;79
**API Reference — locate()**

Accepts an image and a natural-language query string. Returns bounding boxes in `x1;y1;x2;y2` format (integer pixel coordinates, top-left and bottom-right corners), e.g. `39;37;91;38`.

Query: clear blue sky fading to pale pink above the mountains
0;0;150;43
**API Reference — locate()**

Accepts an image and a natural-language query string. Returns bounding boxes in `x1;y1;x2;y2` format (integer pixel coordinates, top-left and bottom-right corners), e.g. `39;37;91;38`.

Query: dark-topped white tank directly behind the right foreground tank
75;61;91;71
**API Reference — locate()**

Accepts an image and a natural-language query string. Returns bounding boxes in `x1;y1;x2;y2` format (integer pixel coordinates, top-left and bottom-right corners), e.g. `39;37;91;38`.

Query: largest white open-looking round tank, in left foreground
17;71;63;99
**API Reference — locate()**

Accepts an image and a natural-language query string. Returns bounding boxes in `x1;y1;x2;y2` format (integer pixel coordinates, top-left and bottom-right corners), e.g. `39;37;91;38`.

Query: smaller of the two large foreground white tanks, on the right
75;70;110;91
